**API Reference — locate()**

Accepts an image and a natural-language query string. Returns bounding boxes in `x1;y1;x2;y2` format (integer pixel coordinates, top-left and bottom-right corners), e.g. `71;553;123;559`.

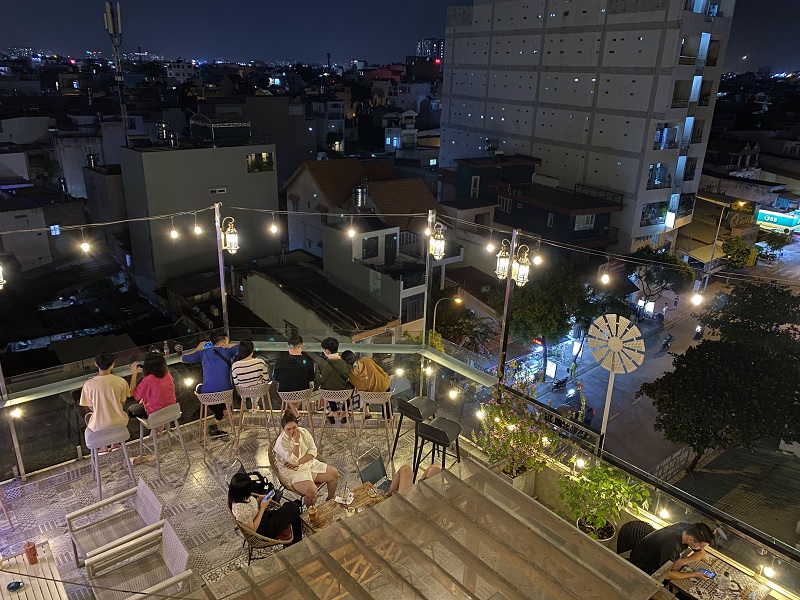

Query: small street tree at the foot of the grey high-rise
628;246;694;301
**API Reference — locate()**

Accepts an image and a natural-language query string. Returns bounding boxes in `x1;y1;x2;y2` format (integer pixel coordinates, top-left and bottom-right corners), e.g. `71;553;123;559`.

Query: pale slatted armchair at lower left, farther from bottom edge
67;479;164;567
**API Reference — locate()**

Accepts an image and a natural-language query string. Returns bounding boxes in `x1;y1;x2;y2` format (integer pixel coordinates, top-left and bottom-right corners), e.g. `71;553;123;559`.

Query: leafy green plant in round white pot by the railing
558;460;650;540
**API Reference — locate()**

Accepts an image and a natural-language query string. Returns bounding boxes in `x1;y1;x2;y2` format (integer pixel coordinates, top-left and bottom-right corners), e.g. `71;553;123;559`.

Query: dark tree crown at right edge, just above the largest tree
694;282;800;344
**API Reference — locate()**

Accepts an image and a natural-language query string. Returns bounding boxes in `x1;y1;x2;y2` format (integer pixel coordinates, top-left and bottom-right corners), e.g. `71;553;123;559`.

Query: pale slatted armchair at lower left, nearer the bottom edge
86;522;192;600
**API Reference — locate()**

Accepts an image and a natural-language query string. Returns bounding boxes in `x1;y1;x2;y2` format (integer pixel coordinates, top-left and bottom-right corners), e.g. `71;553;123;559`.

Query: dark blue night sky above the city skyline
0;0;800;71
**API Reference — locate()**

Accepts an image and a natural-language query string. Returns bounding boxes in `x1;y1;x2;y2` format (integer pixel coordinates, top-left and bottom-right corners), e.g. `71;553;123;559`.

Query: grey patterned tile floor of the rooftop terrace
0;414;422;600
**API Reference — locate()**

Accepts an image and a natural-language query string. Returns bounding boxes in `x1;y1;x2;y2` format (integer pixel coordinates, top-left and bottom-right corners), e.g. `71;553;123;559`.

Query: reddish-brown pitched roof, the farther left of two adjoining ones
302;158;397;206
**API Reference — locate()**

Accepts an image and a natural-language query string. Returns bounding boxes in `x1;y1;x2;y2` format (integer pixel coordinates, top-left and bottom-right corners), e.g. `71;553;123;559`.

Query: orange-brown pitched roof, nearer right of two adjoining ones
369;178;439;233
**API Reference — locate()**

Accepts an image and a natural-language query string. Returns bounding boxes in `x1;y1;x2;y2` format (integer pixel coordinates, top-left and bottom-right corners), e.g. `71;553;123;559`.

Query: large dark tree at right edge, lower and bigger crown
636;340;800;471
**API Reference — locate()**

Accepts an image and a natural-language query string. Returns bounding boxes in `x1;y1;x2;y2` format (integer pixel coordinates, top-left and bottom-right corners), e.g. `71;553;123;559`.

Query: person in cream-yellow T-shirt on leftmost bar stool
80;352;128;452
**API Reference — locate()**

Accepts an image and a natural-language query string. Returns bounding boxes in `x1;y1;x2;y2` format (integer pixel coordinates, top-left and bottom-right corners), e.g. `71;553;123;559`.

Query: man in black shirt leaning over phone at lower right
629;523;714;580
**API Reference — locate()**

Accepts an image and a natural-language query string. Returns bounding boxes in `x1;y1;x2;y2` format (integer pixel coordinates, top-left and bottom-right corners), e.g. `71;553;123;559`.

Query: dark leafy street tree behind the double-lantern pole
489;260;589;365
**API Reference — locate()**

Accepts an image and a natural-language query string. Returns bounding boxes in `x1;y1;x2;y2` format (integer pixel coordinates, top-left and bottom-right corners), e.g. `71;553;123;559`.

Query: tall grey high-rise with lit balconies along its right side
440;0;735;251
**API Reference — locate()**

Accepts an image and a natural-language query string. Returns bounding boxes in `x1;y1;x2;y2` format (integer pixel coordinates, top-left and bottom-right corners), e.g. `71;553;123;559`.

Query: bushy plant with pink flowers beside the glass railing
472;389;558;493
